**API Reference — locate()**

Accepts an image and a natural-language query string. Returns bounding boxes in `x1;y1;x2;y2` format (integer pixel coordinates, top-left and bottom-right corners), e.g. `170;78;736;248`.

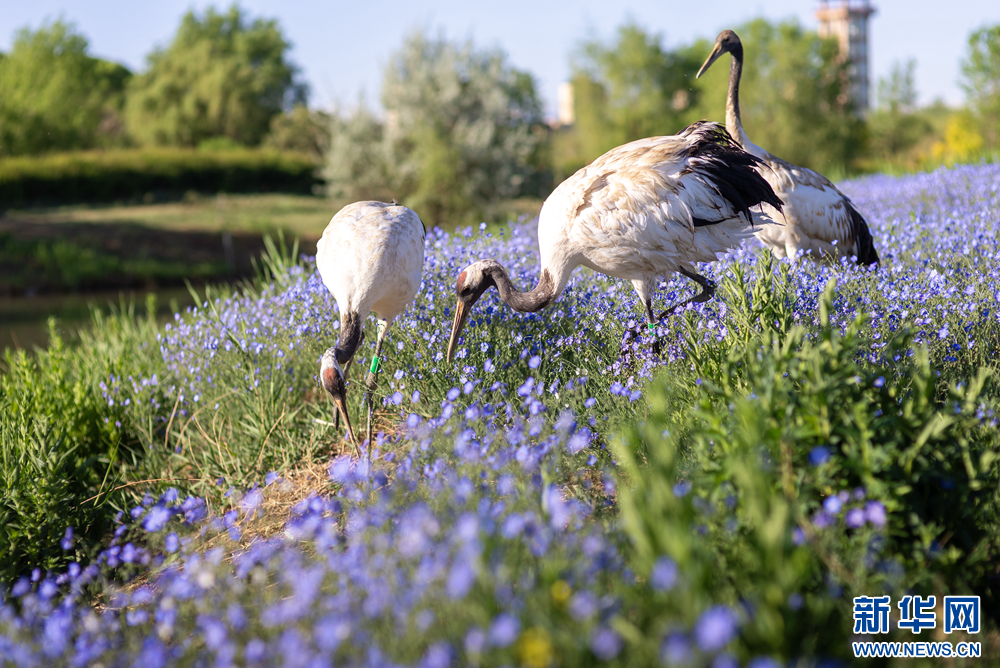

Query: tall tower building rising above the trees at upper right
816;0;875;116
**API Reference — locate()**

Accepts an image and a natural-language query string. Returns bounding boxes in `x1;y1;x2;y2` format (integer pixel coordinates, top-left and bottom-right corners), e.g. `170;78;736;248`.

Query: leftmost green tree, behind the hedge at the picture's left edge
0;20;131;155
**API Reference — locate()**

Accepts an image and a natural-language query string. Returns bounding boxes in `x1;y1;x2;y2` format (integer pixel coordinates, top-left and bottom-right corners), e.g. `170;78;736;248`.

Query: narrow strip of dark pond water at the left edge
0;288;194;351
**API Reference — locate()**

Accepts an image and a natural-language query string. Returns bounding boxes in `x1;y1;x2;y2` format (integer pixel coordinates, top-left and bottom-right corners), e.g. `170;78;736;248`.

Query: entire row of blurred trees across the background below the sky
0;10;1000;214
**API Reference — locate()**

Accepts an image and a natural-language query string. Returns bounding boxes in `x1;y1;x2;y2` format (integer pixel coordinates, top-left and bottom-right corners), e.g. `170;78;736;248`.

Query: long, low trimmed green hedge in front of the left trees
0;148;319;207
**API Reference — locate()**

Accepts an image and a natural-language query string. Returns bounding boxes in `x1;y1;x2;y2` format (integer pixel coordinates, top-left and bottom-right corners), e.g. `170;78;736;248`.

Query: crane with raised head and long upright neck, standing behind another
698;30;879;266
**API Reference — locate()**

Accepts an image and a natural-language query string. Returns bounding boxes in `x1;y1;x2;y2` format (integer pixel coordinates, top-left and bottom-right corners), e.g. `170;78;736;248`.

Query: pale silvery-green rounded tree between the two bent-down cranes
327;33;546;225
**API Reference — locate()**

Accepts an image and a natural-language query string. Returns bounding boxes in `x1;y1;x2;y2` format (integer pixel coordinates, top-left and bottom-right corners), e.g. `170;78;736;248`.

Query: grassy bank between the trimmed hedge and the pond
0;194;336;295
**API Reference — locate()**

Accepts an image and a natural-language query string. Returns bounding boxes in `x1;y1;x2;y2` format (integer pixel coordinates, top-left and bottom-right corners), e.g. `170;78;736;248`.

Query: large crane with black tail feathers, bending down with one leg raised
448;121;781;362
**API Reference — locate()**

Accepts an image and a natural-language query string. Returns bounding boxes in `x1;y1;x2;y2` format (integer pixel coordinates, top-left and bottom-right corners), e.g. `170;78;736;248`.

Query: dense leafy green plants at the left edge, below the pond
0;303;168;582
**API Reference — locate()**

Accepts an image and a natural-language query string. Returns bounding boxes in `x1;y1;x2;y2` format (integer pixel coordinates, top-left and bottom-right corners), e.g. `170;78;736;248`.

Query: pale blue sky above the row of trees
0;0;1000;114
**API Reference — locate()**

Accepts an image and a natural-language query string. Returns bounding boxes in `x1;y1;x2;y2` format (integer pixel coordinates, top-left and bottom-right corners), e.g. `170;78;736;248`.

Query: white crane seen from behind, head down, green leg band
316;200;425;457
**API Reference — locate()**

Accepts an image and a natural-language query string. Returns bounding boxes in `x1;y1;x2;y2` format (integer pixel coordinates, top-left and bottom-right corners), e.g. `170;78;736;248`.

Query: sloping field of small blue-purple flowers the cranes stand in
0;165;1000;668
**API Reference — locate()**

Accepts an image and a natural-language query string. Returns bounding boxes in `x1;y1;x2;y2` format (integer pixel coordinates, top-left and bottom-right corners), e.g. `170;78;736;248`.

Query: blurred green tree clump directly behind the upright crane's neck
555;19;864;174
